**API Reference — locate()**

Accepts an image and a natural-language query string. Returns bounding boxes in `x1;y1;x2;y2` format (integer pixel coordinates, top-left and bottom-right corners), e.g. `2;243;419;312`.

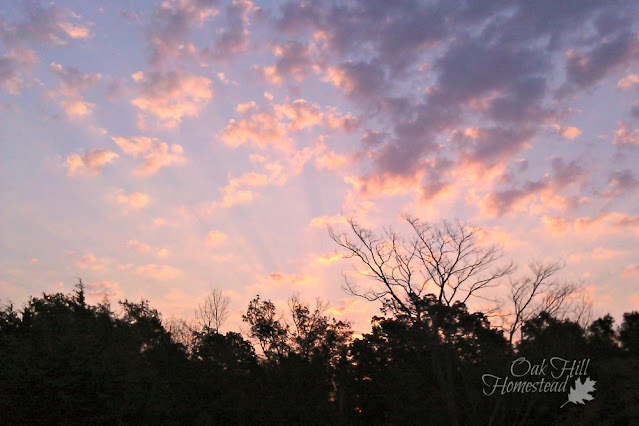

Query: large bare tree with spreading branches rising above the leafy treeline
329;216;515;319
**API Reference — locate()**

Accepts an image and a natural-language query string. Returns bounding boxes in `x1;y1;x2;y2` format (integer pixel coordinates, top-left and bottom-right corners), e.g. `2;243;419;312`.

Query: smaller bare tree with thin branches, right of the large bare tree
504;261;591;344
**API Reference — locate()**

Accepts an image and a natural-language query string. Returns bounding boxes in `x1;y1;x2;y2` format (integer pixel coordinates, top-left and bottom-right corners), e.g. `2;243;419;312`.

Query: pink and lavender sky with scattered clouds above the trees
0;0;639;331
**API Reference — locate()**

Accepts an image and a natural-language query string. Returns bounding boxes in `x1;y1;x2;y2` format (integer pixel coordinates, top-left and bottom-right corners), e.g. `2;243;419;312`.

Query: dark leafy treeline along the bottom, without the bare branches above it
0;285;639;425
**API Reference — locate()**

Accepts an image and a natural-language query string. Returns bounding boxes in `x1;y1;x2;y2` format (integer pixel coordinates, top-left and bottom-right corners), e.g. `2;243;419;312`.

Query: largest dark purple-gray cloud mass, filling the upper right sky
273;0;637;206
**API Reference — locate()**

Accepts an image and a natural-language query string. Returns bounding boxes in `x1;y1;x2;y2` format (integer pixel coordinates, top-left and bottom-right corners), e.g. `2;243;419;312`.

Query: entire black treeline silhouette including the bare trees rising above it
0;216;639;425
